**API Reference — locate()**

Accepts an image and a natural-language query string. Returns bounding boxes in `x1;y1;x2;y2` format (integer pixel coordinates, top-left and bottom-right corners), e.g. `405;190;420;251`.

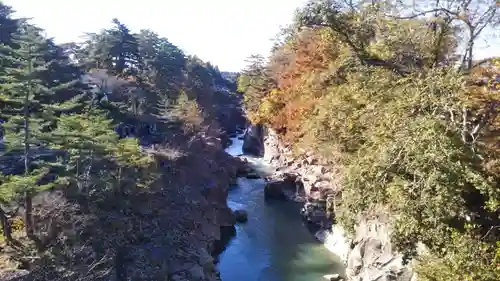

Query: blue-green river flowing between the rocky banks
218;135;344;281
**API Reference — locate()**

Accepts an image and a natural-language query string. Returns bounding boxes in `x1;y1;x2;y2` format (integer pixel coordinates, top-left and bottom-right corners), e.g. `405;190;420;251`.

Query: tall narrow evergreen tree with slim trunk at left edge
1;25;57;243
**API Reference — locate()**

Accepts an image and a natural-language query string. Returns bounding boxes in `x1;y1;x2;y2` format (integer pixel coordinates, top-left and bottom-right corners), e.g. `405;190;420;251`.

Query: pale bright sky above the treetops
0;0;500;71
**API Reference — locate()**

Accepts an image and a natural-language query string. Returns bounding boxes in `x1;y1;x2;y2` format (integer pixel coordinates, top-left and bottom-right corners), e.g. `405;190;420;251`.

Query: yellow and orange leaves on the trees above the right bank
249;3;500;281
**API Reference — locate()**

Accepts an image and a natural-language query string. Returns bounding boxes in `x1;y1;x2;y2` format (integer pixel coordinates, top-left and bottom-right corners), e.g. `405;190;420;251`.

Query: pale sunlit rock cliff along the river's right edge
264;129;416;281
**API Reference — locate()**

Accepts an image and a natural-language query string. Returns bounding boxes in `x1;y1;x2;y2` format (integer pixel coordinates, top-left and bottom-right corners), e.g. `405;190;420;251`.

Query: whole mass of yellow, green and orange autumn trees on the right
239;1;500;281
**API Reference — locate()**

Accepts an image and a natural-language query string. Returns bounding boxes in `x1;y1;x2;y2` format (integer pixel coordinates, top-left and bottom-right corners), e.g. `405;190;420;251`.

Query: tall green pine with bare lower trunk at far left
0;24;80;242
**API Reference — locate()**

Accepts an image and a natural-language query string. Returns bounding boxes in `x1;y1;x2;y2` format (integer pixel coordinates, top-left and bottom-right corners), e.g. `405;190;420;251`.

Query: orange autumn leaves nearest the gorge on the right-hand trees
256;29;342;141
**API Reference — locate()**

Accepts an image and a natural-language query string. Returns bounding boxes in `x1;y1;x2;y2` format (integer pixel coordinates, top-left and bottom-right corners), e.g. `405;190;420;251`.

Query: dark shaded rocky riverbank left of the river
1;130;246;281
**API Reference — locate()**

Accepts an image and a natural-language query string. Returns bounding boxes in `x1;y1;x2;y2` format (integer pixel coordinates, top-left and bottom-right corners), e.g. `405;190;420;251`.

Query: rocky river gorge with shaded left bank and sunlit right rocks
2;122;418;281
